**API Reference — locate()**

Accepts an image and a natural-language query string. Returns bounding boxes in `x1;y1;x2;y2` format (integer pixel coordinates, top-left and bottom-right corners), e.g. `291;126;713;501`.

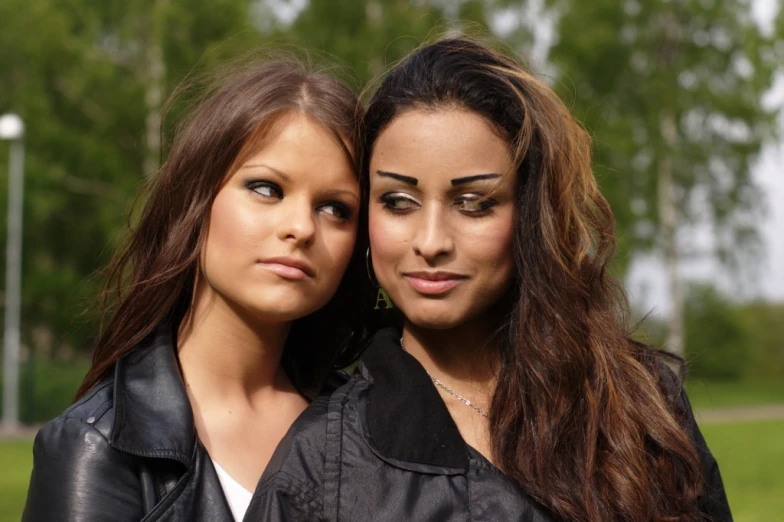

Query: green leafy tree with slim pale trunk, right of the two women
551;0;777;351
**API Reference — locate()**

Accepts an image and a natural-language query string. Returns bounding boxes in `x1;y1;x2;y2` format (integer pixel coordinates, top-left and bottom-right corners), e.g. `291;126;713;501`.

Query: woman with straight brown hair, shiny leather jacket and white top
24;59;361;522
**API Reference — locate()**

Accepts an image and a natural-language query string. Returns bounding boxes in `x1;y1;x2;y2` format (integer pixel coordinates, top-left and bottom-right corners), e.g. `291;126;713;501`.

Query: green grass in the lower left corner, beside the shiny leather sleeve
0;440;33;522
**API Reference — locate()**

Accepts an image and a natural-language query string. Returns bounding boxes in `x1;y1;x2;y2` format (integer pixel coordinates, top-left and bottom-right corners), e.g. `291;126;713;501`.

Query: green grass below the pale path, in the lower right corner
702;420;784;522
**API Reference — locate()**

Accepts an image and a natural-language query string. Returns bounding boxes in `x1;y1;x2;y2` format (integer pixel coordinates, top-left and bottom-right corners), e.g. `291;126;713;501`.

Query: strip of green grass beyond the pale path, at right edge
686;379;784;409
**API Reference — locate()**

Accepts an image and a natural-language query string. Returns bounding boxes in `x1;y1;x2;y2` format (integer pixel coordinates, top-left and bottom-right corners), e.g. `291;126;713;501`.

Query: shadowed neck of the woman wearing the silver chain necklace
403;312;498;396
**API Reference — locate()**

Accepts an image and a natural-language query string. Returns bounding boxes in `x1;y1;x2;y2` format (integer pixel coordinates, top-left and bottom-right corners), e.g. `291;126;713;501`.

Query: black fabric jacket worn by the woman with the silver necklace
245;329;732;522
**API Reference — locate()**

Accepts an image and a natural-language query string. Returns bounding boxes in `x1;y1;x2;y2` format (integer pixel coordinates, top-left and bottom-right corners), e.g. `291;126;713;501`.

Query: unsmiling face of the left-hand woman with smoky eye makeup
202;114;359;321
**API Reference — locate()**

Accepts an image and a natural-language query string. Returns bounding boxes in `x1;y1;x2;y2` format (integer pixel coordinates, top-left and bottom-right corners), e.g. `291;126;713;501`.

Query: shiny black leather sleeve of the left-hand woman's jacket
22;417;144;522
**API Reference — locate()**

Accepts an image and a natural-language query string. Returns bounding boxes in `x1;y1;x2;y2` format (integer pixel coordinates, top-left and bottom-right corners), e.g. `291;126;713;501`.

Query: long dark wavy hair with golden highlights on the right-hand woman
361;38;703;522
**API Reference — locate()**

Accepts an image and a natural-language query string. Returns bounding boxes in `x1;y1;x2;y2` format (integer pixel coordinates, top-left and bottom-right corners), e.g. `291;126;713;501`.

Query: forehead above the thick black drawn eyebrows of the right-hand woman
370;109;511;181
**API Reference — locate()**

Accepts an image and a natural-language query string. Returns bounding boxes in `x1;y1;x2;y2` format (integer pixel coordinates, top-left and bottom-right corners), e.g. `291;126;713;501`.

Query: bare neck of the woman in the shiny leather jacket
177;283;292;408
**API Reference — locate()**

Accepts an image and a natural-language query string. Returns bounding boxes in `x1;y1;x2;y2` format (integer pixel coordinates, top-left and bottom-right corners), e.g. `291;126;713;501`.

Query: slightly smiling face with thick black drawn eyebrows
369;109;515;329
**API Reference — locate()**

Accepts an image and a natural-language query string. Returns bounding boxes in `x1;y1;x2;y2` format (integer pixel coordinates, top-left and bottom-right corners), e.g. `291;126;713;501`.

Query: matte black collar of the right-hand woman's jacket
361;328;468;470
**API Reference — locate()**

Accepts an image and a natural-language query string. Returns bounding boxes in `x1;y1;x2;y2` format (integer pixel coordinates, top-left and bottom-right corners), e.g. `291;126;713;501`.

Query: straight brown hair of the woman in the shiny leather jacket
76;58;361;398
